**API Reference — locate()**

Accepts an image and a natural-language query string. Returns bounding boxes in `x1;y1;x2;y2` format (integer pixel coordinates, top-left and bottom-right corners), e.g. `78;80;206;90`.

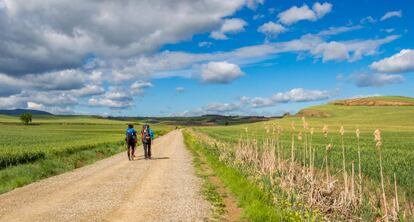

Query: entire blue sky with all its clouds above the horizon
0;0;414;116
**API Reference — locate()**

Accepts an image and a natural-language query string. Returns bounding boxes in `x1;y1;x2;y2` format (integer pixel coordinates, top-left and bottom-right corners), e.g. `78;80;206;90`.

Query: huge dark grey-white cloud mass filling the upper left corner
0;0;249;75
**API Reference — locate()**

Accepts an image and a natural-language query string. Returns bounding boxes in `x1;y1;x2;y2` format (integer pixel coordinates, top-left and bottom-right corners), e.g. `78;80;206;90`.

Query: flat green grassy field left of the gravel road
0;116;173;193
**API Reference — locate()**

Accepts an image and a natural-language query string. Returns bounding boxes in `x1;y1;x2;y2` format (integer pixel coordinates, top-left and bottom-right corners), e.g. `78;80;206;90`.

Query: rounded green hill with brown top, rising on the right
296;96;414;130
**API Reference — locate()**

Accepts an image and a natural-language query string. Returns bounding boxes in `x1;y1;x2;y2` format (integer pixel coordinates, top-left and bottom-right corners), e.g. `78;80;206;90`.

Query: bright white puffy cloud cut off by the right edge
370;49;414;73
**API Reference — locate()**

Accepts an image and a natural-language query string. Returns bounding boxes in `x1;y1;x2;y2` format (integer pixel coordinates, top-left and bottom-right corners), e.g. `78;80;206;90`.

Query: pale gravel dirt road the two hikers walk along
0;130;210;222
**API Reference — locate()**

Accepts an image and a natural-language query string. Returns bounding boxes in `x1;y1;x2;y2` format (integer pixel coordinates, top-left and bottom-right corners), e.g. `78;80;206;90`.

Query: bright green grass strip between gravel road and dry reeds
184;131;316;221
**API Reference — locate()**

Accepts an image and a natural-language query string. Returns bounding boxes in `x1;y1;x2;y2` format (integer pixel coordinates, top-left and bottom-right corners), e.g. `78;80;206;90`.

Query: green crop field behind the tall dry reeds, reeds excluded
196;97;414;219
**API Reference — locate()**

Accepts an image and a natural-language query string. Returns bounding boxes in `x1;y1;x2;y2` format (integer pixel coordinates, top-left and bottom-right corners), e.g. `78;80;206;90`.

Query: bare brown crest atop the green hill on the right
330;96;414;106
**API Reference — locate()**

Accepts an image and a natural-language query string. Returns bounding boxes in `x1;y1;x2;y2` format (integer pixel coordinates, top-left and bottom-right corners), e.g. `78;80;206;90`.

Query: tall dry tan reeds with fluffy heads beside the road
189;119;413;221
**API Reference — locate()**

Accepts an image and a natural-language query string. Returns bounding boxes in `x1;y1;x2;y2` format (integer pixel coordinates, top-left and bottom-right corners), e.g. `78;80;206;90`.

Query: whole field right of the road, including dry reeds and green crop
195;98;414;220
